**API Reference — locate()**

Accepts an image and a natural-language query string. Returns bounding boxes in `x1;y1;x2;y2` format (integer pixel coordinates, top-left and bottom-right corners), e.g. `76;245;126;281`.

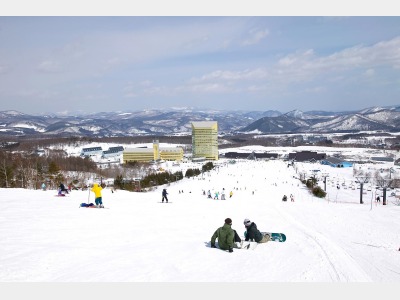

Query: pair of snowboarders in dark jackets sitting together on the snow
211;218;271;252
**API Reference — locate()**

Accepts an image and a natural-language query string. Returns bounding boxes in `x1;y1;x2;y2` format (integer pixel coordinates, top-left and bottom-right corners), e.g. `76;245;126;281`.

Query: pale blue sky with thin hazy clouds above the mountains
0;16;400;114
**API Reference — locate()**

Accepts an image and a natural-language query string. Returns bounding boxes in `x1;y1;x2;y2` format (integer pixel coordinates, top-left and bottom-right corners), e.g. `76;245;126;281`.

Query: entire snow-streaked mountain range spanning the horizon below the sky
0;106;400;137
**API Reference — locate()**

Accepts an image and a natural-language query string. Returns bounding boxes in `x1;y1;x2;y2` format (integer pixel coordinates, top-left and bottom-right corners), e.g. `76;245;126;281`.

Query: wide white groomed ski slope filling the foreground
0;155;400;283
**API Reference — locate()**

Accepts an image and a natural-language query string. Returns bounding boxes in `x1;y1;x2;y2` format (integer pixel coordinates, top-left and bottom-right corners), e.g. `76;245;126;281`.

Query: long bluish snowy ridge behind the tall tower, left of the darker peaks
0;108;281;137
